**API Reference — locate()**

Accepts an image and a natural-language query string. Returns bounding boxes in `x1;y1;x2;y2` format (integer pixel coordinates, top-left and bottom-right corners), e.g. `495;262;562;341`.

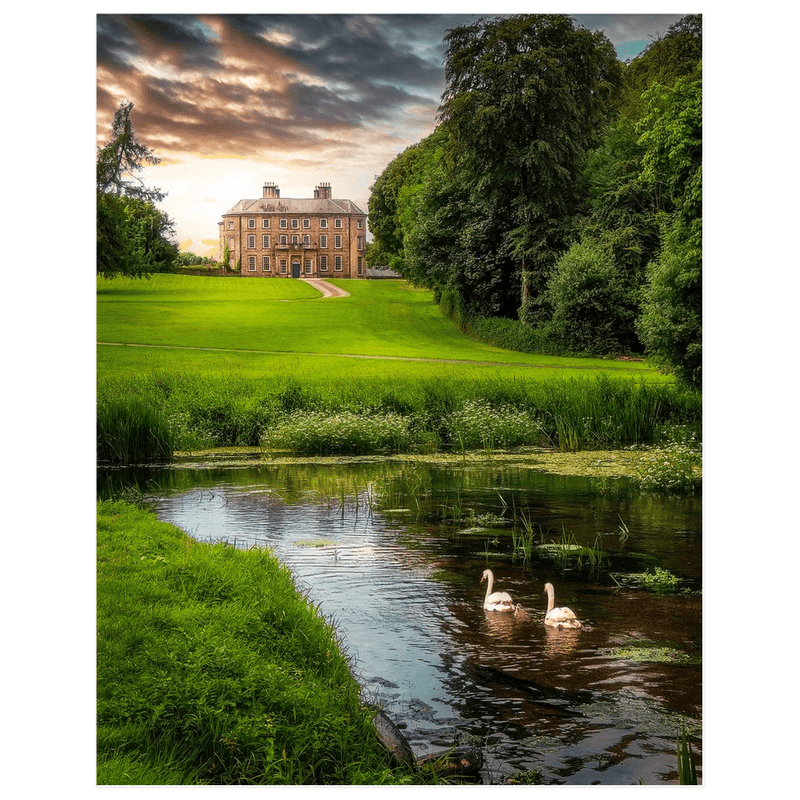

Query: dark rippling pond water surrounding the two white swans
99;459;702;785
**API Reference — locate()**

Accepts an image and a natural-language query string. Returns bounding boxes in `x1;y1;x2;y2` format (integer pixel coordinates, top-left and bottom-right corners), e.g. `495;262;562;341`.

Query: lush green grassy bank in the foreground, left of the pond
97;503;419;785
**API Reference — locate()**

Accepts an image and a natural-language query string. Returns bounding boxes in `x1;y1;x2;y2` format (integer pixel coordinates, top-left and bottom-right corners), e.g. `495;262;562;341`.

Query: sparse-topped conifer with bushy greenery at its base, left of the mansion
97;103;178;278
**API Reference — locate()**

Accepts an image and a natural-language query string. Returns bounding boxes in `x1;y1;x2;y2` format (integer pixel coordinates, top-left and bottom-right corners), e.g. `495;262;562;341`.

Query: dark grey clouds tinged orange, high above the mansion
97;15;441;162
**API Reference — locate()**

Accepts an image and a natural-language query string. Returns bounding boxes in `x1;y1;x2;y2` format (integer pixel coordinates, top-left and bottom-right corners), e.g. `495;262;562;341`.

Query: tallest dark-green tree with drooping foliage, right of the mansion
440;14;621;319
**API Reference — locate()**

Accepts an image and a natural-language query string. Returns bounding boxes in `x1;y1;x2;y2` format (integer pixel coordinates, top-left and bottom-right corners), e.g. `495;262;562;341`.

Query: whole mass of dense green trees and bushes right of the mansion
367;14;702;387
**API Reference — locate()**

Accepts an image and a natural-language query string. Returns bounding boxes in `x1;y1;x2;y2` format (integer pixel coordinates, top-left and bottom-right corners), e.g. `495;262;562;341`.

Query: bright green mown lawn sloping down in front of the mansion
97;275;667;382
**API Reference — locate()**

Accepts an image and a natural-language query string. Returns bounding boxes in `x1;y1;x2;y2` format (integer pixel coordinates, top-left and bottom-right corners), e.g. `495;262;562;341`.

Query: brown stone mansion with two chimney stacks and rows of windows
219;183;367;278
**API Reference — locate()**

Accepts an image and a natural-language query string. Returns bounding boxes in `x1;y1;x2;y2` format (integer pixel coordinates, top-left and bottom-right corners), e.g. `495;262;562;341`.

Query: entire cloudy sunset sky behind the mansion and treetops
97;12;689;255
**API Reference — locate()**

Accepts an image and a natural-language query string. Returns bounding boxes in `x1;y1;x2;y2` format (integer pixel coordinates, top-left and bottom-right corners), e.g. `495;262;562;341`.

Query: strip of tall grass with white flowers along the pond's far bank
98;373;701;460
